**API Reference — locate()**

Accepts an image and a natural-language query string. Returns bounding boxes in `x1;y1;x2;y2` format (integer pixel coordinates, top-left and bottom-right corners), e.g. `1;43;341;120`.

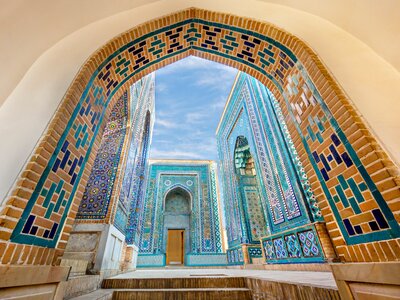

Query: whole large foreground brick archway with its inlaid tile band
1;8;399;264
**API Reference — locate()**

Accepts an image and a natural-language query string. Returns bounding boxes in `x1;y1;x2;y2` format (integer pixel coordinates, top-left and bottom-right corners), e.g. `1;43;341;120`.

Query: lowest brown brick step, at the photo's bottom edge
112;288;251;300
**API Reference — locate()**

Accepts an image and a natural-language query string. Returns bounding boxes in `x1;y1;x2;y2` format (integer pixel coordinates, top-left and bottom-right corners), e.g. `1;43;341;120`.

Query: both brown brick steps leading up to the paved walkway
102;275;251;300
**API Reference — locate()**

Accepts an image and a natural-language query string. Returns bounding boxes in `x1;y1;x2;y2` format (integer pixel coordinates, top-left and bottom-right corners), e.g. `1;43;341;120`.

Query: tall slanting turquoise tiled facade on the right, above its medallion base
217;73;320;247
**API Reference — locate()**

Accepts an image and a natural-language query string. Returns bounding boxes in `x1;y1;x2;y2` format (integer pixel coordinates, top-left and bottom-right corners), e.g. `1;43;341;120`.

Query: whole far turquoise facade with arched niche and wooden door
138;160;226;267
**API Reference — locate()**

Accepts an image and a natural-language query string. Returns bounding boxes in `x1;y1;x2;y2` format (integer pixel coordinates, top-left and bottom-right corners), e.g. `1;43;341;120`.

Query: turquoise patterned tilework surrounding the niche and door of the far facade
139;160;222;266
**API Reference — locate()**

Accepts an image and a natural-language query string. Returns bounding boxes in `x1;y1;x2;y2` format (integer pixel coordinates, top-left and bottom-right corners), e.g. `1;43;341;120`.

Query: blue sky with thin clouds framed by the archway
150;56;238;160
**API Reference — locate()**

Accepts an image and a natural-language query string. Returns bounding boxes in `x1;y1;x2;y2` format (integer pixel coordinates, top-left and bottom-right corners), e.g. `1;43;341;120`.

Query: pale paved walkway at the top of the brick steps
112;268;337;289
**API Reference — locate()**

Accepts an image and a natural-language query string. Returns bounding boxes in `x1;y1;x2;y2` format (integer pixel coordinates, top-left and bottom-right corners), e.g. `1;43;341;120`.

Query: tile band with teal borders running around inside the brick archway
10;11;400;253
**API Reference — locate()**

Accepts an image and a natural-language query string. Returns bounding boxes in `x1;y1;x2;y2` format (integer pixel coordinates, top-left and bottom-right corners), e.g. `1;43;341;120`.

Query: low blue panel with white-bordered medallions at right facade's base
261;224;325;263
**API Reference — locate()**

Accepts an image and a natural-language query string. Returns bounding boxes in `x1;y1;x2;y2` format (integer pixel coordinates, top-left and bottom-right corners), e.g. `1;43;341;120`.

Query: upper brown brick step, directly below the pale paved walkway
102;275;246;289
